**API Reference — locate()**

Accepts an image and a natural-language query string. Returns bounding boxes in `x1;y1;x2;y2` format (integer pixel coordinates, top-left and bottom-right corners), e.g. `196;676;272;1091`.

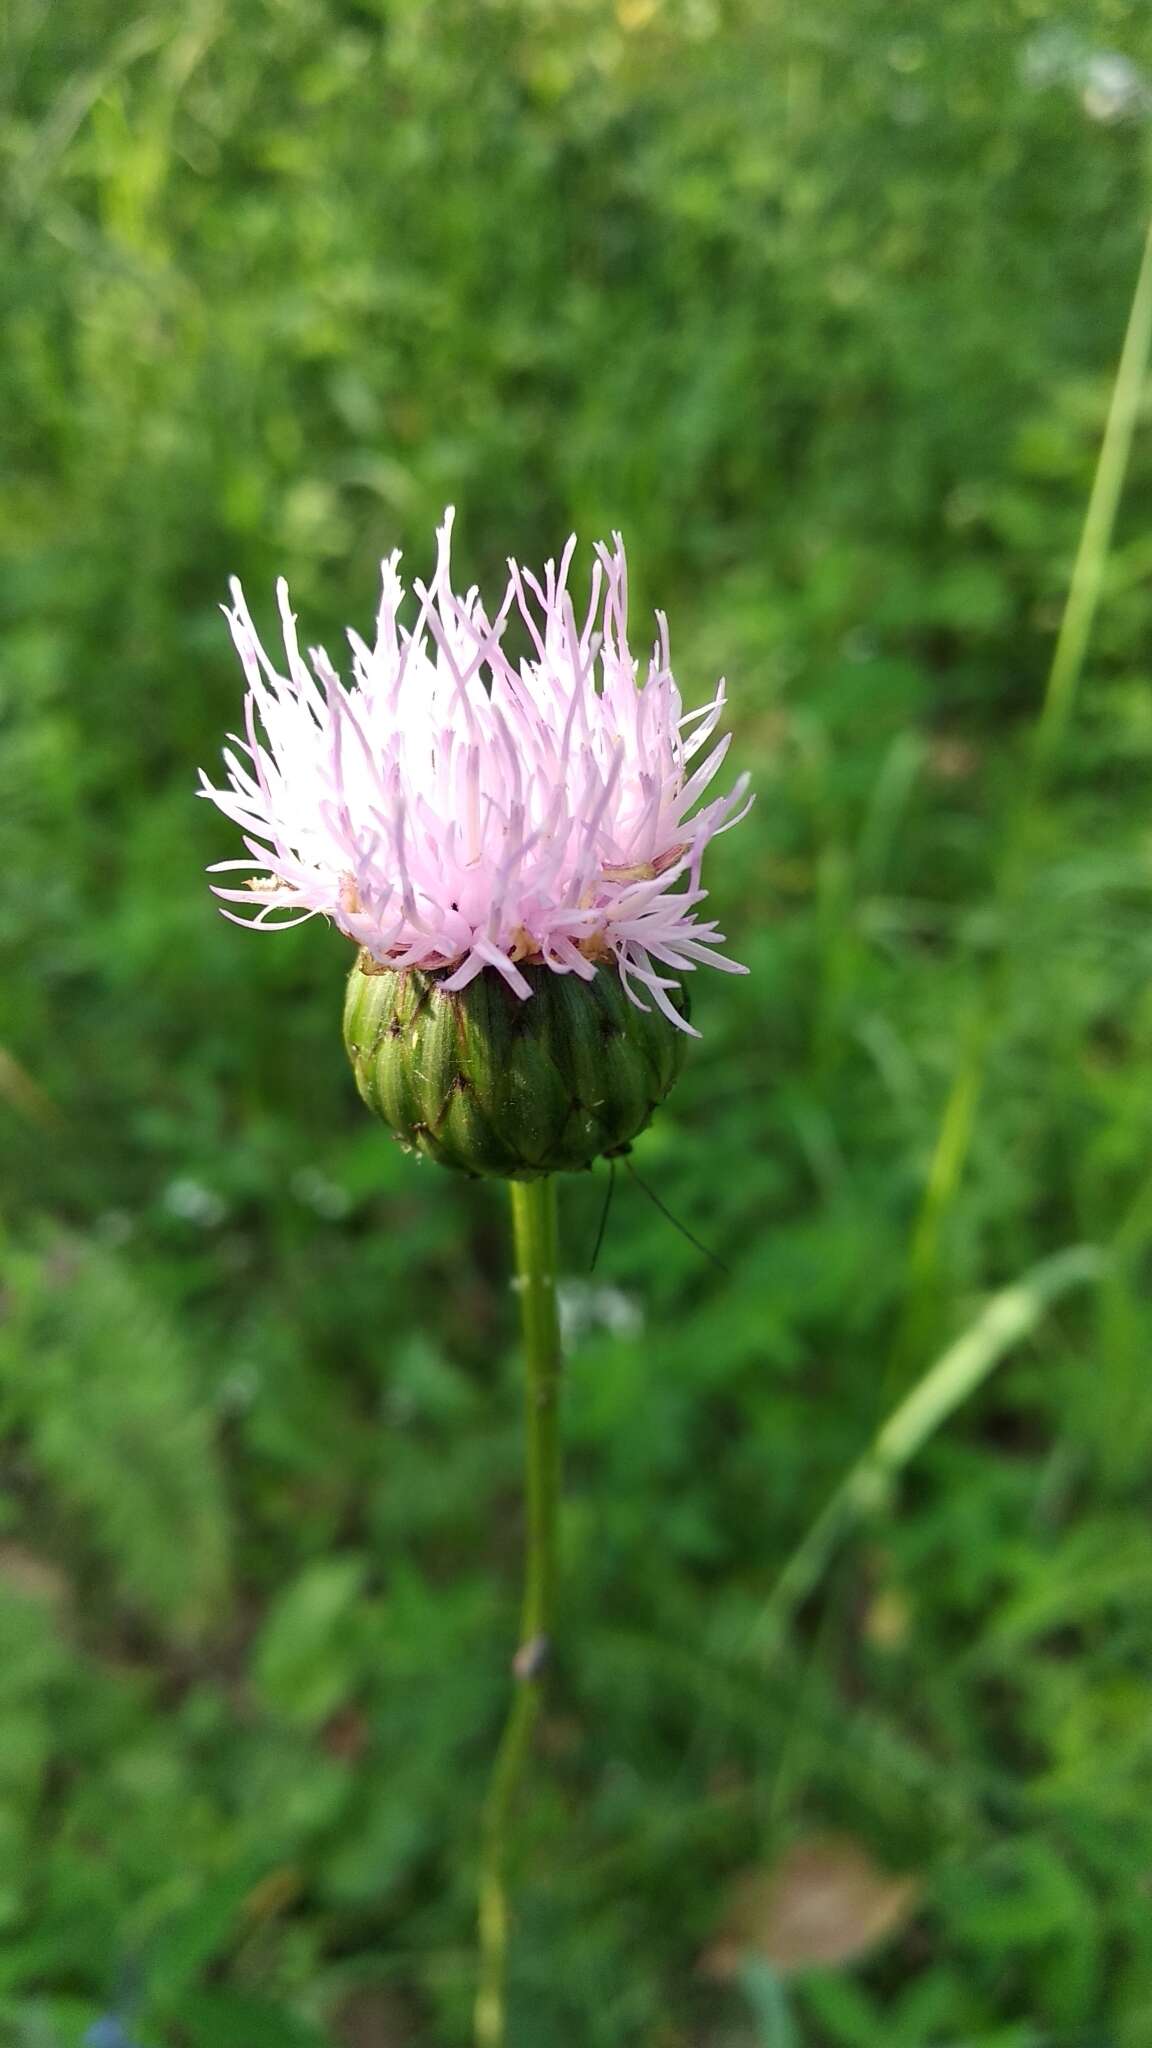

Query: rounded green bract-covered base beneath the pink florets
344;954;687;1180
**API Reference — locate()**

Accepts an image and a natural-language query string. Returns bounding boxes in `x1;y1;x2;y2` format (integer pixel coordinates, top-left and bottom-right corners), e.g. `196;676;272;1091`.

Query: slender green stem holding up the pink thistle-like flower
476;1178;560;2048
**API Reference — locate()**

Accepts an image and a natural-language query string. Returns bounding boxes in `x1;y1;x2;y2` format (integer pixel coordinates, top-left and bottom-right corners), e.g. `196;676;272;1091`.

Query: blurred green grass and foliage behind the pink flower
0;0;1152;2048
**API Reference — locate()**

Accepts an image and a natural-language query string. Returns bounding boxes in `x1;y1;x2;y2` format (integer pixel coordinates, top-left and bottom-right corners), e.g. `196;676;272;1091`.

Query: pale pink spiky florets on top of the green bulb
201;510;750;1030
